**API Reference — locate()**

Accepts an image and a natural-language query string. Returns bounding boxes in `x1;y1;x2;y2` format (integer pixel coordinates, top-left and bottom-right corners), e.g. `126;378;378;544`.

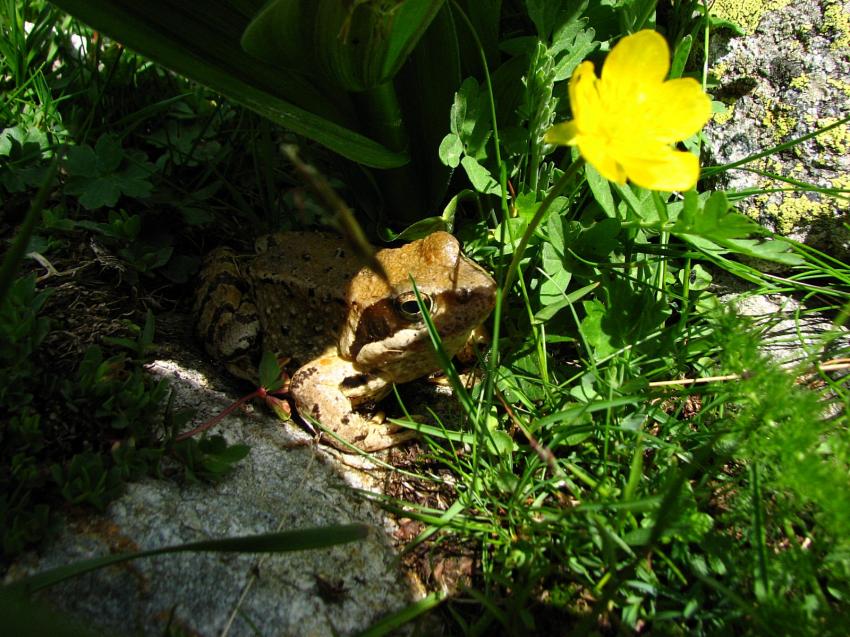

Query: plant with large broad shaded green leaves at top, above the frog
46;0;459;221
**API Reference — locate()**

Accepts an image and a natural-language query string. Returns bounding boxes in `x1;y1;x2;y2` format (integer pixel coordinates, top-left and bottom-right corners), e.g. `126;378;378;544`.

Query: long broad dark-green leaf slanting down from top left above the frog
49;0;409;168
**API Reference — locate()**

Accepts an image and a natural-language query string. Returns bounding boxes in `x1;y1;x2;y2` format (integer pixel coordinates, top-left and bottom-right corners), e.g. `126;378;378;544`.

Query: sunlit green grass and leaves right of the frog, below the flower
390;3;850;635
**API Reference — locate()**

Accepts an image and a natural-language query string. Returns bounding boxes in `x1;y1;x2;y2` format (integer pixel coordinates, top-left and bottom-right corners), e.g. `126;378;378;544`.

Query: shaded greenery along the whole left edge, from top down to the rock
0;0;288;559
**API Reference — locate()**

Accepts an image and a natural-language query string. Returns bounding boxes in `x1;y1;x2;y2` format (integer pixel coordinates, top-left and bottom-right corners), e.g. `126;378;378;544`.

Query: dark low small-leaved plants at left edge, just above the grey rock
0;296;248;557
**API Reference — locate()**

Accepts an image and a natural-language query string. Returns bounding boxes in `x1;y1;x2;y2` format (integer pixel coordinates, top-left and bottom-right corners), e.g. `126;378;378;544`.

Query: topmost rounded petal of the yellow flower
602;29;670;85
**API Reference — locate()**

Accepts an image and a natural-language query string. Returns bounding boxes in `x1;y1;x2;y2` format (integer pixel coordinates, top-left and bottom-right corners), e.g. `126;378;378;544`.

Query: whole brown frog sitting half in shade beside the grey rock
195;232;496;451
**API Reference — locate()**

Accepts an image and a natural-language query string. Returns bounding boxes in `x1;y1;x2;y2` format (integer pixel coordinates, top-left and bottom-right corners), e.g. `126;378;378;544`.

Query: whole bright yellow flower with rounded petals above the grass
545;31;711;191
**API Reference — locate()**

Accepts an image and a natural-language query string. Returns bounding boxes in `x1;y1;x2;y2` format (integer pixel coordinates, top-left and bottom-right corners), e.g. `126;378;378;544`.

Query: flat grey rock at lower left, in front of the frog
7;361;414;636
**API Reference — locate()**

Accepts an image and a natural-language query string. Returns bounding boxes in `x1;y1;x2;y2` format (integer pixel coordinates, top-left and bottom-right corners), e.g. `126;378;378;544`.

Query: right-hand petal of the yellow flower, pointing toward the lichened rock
647;77;711;144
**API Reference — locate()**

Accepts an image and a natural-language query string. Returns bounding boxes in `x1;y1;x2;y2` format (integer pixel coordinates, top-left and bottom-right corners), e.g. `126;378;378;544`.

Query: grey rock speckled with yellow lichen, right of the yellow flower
707;0;850;258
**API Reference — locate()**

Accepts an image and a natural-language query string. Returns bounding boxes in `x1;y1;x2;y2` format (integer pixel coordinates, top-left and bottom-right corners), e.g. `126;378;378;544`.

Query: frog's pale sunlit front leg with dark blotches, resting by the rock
289;351;416;451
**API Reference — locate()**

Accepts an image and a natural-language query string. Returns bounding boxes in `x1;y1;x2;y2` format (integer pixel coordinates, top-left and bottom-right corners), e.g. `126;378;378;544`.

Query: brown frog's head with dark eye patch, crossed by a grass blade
340;232;496;383
